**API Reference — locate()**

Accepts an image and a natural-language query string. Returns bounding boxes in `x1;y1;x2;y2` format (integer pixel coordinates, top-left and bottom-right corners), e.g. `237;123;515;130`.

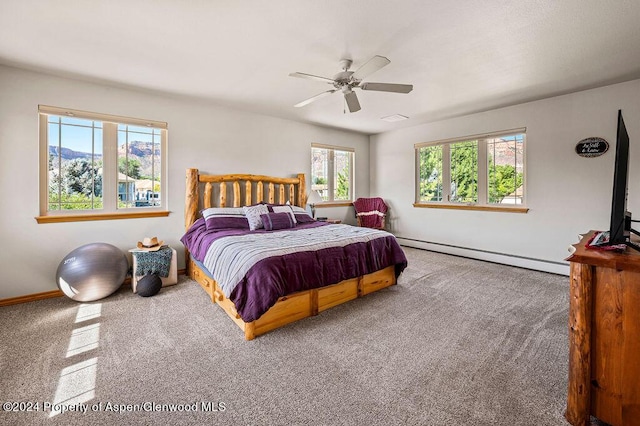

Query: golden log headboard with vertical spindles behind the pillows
184;169;307;229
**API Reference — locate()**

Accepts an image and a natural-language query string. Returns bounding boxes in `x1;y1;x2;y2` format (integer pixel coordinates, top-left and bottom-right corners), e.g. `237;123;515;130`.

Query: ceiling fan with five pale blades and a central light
289;56;413;112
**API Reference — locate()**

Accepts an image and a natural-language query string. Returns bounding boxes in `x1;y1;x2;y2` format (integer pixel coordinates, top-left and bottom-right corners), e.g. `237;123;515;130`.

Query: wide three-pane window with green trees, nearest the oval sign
415;129;526;211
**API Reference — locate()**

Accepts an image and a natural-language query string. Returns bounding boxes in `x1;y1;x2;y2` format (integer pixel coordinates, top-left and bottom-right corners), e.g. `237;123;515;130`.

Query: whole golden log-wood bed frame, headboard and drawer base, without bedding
185;169;396;340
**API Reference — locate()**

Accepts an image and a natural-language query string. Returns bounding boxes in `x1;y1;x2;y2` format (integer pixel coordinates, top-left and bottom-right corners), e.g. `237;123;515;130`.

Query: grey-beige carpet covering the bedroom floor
0;248;588;426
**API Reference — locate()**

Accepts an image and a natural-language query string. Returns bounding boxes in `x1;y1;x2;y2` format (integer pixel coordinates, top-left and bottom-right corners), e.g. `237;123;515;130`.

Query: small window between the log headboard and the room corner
311;144;354;203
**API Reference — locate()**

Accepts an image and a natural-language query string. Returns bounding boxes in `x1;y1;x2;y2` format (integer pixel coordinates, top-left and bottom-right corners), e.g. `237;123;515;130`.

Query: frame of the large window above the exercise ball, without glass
36;105;169;223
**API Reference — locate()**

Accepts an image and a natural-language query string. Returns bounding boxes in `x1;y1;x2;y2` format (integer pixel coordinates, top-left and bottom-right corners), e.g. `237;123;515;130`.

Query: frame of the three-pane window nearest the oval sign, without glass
414;128;529;213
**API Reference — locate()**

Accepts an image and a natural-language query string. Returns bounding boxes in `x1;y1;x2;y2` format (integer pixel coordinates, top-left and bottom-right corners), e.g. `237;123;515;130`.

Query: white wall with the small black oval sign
370;80;640;274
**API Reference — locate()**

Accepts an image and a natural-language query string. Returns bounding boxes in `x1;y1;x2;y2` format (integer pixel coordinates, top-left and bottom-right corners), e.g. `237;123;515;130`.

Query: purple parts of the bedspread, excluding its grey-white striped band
181;219;407;322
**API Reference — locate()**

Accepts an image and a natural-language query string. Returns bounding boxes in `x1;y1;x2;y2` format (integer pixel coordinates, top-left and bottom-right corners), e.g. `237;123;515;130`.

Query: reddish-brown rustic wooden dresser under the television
565;231;640;426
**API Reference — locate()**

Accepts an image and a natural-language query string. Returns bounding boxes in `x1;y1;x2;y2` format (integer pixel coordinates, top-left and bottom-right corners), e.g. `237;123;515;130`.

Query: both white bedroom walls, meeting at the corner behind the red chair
0;66;640;299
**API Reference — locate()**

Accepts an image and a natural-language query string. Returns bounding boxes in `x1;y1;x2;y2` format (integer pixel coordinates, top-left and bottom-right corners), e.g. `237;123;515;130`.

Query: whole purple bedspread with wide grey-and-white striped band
181;218;407;322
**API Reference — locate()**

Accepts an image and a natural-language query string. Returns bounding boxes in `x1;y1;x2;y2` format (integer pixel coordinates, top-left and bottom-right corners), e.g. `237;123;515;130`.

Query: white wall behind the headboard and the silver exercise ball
0;66;370;299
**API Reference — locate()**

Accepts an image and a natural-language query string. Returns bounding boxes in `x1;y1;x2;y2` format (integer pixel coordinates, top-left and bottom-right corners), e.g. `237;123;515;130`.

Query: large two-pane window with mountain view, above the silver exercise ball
37;106;168;222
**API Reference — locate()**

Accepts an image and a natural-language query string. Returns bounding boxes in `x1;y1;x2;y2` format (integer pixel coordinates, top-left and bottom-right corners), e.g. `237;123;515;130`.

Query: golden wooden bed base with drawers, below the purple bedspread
188;259;396;340
